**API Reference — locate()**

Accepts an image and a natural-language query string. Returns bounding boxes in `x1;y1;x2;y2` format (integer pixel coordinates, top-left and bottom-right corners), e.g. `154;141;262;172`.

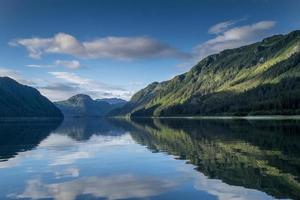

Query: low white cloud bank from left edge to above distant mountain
0;66;135;101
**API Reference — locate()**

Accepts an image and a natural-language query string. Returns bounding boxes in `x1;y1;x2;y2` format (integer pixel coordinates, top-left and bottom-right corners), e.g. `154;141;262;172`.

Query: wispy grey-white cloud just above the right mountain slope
195;21;276;59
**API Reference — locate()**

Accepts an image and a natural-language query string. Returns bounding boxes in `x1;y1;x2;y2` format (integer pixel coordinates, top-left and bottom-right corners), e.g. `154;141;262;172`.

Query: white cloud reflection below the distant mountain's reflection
0;133;134;169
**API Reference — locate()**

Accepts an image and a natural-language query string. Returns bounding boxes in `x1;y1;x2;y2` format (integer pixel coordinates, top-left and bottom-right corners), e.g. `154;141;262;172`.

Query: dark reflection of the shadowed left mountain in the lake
0;120;61;161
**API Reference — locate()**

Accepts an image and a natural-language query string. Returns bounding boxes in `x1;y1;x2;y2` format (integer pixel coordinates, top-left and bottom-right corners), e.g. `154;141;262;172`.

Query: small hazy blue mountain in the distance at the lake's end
55;94;124;117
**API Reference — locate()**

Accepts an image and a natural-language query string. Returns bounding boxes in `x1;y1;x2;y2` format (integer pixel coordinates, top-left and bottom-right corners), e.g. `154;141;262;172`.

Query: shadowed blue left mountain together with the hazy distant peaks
0;77;127;118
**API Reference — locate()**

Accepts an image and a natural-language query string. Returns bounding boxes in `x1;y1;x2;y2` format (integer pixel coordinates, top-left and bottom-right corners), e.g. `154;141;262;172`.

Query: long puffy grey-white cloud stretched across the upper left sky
9;33;189;60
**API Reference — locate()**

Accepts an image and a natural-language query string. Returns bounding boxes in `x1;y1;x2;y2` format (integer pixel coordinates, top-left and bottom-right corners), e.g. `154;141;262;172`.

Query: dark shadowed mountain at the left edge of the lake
0;77;63;118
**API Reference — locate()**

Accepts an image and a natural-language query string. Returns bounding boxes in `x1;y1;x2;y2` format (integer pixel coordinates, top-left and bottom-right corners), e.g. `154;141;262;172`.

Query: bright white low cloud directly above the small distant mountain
38;72;132;101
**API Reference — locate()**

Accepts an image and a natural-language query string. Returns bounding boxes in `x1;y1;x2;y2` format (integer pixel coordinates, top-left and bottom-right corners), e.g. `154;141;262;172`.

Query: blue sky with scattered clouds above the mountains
0;0;300;101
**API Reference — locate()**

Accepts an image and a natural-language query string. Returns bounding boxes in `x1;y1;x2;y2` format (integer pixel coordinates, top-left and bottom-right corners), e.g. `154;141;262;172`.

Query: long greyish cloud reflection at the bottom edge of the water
14;174;177;200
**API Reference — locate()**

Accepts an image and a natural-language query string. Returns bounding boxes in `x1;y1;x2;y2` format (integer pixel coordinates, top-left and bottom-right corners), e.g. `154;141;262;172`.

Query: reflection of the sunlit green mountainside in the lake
123;119;300;199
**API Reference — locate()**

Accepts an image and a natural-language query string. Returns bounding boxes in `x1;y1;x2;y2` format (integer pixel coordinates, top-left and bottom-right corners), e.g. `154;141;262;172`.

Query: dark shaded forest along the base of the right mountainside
144;78;300;116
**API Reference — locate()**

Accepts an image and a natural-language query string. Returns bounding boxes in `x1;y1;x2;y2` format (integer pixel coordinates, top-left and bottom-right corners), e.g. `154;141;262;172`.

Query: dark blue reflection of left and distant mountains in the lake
0;118;125;161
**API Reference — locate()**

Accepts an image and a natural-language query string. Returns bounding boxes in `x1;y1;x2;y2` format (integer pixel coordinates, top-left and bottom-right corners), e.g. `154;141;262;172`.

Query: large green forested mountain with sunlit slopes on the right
110;30;300;117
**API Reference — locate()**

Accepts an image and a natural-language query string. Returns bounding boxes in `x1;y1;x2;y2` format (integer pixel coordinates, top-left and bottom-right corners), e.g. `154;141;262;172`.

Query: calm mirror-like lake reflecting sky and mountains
0;119;300;200
